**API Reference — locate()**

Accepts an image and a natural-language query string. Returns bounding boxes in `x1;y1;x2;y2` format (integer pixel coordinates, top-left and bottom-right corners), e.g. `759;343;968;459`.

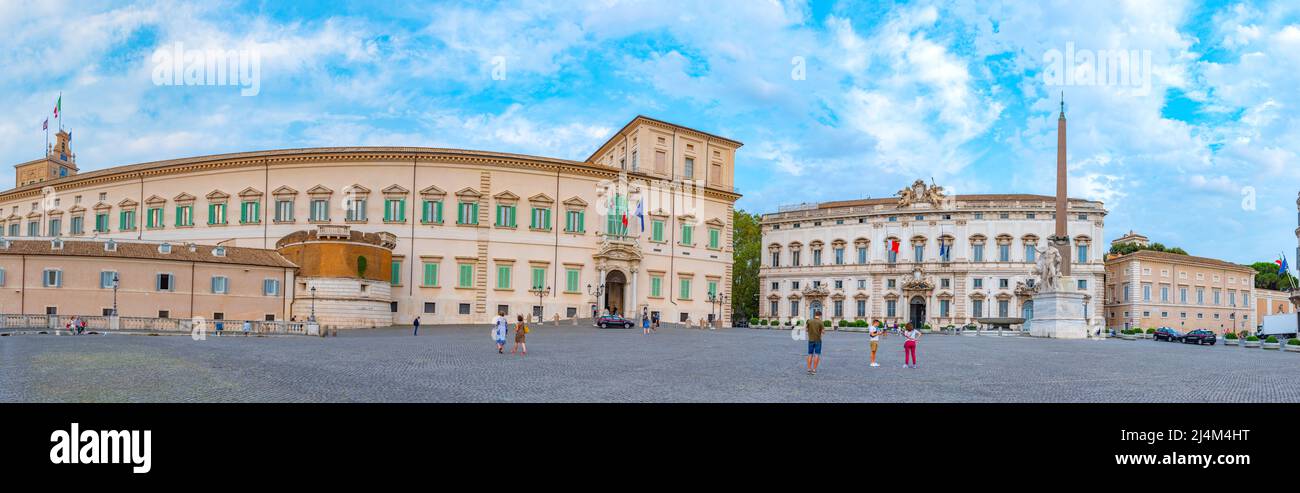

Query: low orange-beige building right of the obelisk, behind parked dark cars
1105;232;1258;333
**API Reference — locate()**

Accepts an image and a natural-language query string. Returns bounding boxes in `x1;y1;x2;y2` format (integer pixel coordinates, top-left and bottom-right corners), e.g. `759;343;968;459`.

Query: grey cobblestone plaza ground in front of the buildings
0;325;1300;402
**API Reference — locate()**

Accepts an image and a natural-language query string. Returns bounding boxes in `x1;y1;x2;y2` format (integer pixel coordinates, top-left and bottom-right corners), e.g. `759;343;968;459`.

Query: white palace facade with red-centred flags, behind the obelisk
759;180;1106;328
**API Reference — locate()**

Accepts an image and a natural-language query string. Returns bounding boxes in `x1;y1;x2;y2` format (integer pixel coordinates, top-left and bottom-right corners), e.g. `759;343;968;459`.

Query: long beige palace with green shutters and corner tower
0;116;741;324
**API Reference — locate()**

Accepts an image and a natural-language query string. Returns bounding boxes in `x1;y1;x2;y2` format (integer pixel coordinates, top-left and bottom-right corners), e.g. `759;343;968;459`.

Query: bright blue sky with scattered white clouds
0;0;1300;264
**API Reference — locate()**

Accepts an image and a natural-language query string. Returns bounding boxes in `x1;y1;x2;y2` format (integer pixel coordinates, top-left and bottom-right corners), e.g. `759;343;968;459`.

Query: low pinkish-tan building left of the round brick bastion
0;239;296;320
